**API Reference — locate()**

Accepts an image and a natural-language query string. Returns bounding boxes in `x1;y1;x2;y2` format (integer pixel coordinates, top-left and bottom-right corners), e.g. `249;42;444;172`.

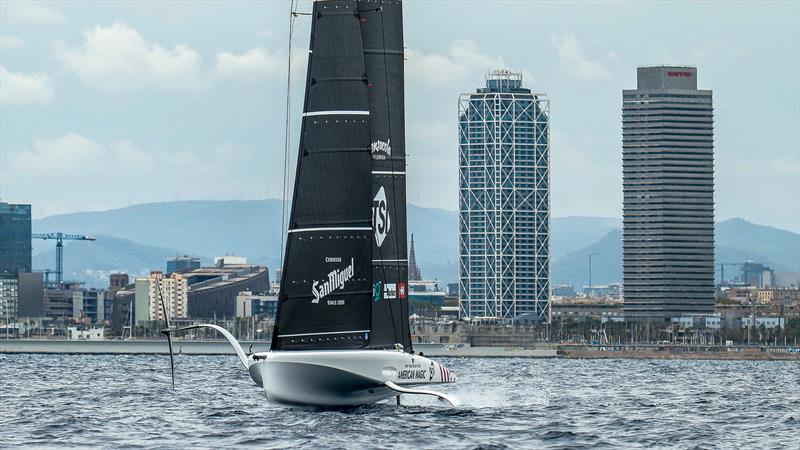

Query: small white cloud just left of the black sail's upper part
215;48;286;81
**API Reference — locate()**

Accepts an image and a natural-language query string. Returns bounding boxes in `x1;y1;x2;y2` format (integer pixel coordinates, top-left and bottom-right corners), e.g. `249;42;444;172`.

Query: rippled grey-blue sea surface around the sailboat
0;355;800;449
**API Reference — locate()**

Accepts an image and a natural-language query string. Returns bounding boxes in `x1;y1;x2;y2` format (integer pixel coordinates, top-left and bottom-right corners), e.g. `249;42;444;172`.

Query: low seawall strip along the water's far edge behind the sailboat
0;339;800;361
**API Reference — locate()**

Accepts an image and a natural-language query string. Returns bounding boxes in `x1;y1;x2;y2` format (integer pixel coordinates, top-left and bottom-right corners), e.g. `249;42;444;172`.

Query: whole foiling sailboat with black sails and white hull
165;0;457;406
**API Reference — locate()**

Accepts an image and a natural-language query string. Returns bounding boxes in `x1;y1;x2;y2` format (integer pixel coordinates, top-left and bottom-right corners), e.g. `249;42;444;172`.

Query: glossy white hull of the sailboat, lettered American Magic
248;350;455;406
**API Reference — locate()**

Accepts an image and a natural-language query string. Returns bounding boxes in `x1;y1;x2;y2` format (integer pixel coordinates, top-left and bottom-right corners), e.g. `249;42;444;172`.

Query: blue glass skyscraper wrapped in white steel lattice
458;70;550;321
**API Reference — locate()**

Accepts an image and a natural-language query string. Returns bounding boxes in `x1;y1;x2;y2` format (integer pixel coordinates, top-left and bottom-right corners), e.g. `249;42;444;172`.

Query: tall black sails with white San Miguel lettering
272;0;411;351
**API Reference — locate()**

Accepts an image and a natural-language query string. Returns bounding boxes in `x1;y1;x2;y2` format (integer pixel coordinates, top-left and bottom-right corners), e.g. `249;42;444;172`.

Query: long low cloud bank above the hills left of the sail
2;132;280;216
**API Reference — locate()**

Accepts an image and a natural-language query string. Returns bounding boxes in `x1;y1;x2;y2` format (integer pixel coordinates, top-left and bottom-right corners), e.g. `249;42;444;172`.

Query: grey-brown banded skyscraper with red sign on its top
622;66;714;319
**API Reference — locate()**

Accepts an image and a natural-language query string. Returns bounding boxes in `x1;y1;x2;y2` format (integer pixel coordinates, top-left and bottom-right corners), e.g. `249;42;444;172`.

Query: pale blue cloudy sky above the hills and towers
0;0;800;232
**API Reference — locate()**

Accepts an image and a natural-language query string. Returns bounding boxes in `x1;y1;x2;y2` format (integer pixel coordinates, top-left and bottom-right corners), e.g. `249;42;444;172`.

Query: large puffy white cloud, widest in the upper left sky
56;22;205;90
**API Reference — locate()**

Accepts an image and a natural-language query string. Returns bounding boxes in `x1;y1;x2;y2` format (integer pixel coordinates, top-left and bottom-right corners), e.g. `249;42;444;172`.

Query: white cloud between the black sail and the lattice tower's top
406;40;507;88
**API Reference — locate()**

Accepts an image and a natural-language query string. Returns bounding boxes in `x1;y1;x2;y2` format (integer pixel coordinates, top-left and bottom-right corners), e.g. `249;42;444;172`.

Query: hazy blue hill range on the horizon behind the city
33;200;800;287
